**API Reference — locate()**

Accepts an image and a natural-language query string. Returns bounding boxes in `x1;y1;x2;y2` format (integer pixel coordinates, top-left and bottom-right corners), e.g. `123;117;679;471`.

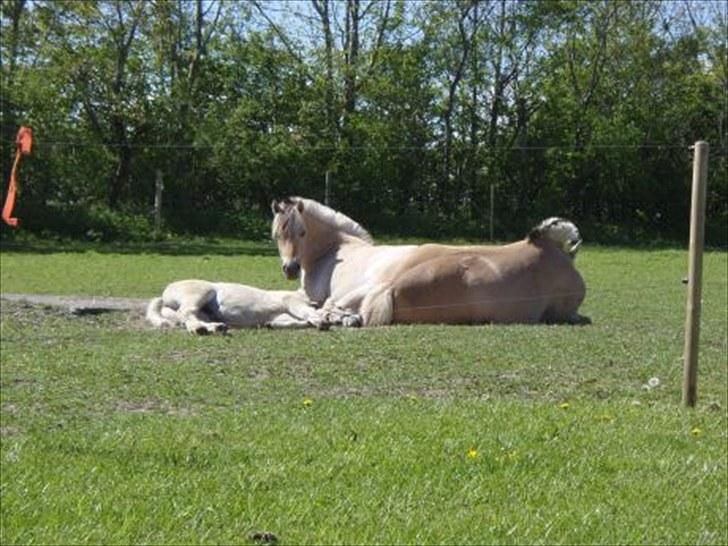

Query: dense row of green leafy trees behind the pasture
0;0;728;242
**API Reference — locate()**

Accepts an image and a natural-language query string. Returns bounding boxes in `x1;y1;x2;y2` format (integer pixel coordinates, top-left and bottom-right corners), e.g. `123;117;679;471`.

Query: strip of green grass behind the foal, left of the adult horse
0;239;284;297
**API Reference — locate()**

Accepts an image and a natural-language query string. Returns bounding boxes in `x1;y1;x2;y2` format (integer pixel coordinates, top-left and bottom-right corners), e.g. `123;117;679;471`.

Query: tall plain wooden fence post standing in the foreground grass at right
683;141;708;407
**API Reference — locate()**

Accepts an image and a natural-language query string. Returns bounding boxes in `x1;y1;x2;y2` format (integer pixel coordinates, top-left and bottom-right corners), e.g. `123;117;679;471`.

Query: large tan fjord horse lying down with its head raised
272;197;588;326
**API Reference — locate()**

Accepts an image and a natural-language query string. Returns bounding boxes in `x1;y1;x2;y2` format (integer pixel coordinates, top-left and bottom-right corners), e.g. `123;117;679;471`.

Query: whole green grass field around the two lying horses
0;236;728;544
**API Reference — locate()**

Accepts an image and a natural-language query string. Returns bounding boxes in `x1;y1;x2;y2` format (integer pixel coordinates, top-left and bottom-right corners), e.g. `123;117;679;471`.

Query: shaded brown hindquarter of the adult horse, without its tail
393;242;578;323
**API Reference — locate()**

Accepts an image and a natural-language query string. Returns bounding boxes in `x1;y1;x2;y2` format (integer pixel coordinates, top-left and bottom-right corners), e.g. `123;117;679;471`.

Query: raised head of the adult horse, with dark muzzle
271;199;306;280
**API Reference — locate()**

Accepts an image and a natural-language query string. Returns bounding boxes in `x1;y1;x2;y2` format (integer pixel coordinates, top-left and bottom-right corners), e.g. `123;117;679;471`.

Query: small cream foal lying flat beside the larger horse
146;280;329;334
